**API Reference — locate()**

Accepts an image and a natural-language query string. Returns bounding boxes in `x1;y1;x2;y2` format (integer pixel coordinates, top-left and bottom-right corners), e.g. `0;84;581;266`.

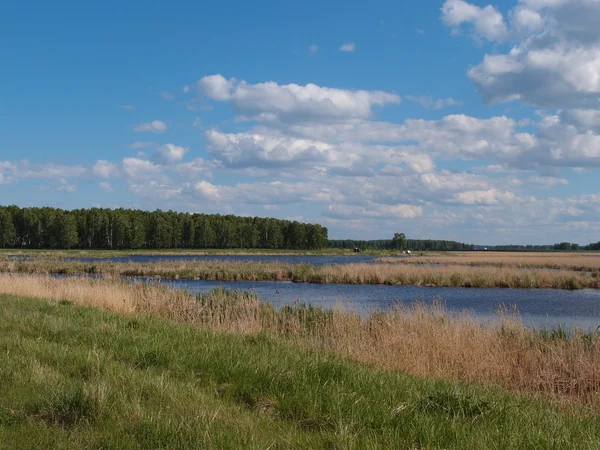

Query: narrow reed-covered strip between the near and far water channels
0;259;600;289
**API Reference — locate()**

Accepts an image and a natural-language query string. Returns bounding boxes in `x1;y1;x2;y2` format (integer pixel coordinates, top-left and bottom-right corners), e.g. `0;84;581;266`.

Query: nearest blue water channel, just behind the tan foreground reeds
145;280;600;330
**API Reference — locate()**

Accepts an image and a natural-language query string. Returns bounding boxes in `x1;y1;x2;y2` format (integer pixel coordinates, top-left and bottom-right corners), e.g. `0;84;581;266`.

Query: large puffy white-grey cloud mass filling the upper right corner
442;0;600;109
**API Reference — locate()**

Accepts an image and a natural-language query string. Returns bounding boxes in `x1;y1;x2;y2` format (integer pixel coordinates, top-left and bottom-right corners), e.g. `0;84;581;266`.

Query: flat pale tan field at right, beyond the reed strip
377;252;600;272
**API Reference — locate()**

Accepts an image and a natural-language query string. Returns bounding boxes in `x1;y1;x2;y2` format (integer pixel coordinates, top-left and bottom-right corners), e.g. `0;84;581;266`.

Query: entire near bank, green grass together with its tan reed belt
0;274;600;450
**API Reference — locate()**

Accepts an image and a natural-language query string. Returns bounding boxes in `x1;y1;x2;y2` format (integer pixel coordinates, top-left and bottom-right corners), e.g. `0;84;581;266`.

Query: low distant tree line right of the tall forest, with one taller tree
328;237;476;251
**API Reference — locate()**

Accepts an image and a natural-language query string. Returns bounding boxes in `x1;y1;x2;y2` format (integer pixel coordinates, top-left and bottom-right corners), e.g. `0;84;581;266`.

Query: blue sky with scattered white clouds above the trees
0;0;600;245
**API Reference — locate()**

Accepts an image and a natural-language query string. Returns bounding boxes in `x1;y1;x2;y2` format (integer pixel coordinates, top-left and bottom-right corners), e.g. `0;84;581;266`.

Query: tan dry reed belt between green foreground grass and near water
0;274;600;405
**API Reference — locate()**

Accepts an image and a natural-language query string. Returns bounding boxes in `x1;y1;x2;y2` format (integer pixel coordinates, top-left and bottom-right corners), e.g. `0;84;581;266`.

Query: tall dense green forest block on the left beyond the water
0;206;327;250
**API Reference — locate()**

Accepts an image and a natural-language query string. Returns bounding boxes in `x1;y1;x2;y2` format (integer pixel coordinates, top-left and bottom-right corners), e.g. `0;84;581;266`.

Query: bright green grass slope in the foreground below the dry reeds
0;296;600;449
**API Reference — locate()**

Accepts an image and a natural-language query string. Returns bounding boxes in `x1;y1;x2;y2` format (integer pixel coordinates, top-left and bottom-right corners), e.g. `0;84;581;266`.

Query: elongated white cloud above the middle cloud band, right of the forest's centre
198;75;400;121
